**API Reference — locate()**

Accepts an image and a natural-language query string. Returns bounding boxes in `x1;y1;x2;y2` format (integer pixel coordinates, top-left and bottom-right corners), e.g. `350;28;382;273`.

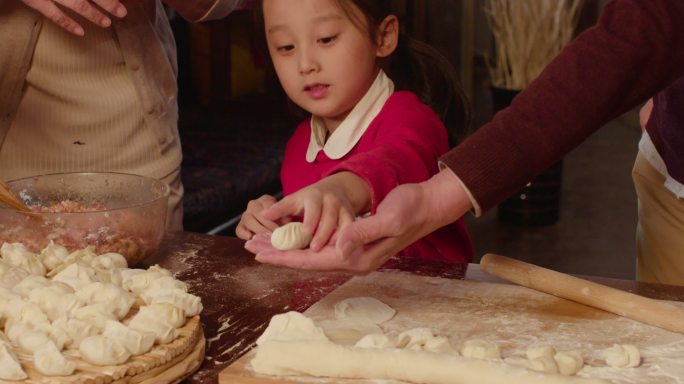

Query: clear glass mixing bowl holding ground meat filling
0;172;169;265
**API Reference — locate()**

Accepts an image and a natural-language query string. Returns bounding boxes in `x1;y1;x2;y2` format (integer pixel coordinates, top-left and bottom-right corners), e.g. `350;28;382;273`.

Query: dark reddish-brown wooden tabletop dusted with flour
145;232;684;384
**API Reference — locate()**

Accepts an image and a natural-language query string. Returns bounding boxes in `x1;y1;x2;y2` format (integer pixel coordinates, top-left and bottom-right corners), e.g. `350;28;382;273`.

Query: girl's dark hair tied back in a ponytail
337;0;471;146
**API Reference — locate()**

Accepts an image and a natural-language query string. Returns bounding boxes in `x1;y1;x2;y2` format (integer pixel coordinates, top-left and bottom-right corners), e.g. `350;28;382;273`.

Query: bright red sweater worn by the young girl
280;91;473;262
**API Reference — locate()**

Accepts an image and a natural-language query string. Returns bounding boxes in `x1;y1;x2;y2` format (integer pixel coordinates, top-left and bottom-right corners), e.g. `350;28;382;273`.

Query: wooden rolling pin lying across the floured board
480;253;684;333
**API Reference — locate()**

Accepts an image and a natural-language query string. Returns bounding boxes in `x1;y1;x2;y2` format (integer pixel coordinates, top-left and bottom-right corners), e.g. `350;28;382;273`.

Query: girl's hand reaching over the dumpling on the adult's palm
261;178;356;251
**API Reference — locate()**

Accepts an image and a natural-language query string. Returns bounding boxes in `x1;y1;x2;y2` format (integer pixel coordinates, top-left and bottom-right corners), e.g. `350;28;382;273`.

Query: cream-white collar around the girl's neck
306;70;394;163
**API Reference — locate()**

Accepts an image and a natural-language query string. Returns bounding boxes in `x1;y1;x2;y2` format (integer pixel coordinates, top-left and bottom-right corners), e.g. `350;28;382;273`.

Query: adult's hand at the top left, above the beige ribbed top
21;0;127;36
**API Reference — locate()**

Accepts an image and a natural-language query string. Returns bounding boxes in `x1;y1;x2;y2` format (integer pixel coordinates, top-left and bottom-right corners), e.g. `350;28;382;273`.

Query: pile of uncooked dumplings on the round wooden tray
0;243;202;380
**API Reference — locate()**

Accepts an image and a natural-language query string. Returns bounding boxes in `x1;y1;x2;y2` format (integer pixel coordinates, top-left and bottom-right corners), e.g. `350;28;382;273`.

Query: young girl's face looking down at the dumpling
263;0;383;132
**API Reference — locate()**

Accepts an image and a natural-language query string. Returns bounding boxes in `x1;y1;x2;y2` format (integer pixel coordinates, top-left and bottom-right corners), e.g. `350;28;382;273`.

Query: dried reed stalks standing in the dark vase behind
484;0;583;90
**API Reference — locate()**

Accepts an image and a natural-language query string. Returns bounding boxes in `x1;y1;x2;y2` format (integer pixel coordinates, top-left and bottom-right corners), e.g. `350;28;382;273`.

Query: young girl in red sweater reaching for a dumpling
236;0;473;262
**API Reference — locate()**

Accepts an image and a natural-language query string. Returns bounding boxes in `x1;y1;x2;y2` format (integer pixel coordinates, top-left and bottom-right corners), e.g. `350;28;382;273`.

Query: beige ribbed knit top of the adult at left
0;10;164;180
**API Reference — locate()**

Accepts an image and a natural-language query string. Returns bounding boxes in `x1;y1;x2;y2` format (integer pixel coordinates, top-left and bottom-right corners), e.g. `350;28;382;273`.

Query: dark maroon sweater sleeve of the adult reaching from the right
440;0;684;211
